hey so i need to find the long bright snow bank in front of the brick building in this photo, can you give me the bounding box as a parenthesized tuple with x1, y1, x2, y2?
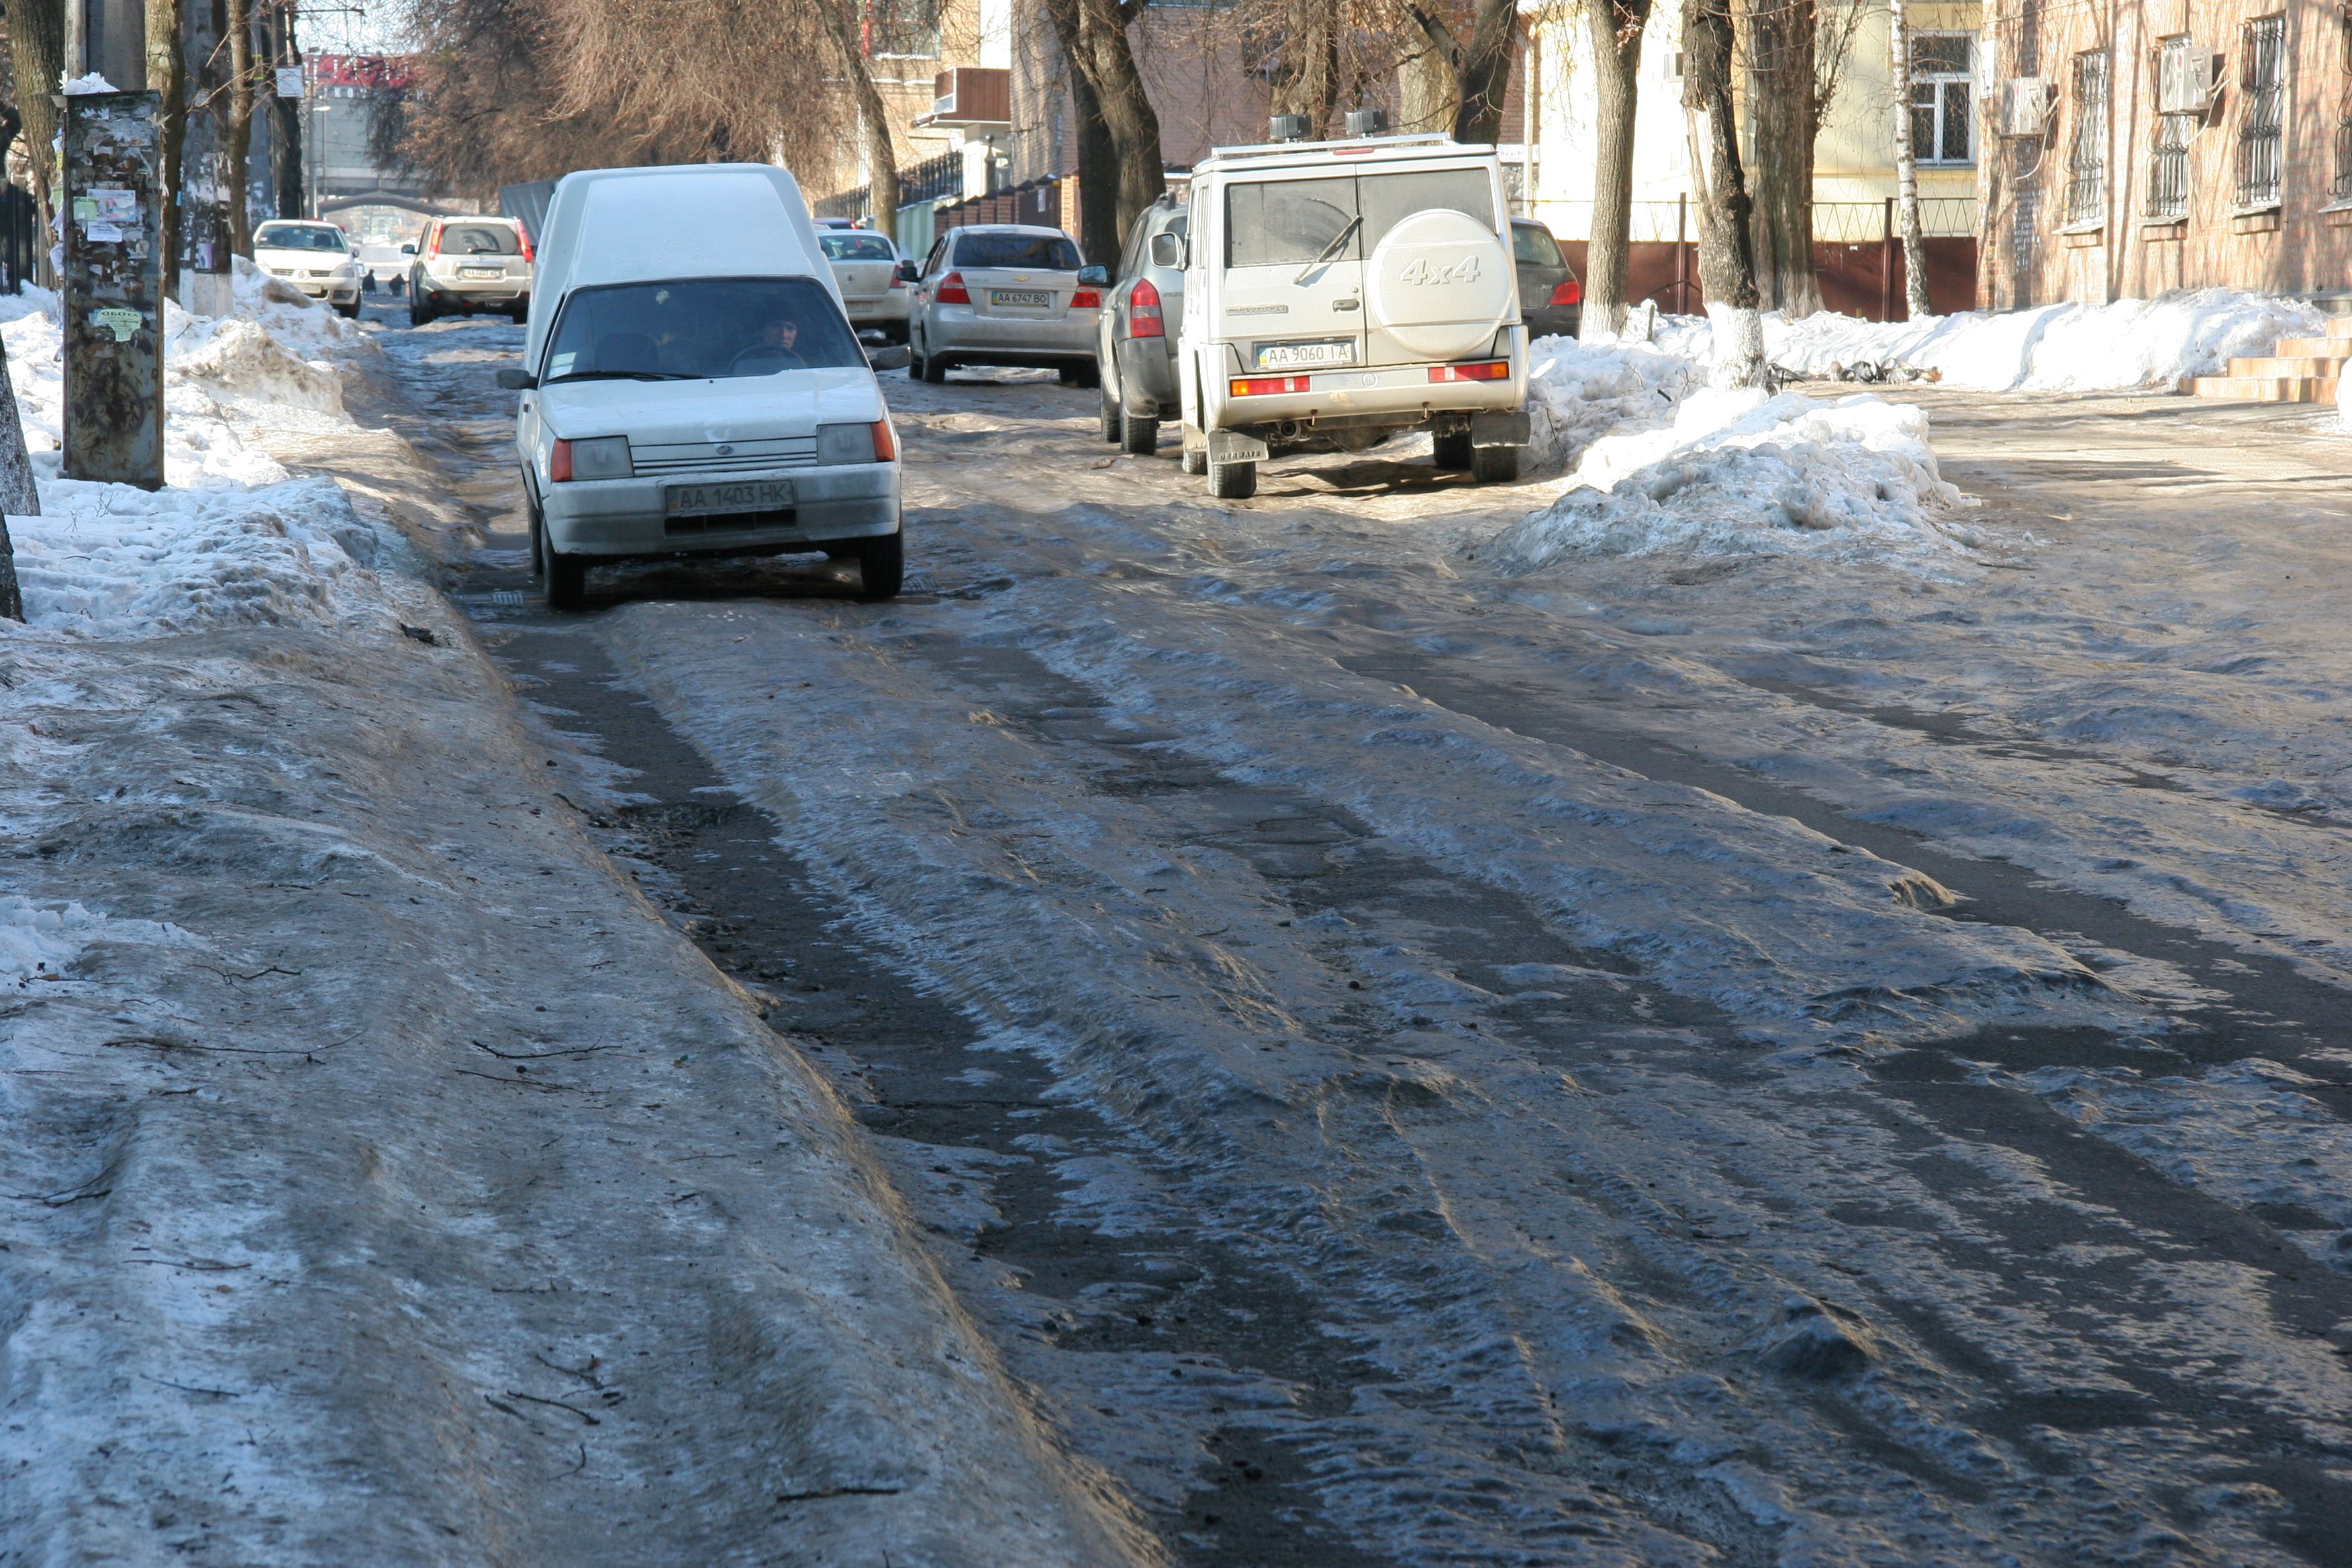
(1764, 289, 2326, 393)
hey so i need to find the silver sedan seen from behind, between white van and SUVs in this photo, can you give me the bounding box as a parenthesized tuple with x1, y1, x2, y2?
(910, 224, 1103, 385)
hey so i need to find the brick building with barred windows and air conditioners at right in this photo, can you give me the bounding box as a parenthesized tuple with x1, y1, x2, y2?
(1978, 0, 2352, 308)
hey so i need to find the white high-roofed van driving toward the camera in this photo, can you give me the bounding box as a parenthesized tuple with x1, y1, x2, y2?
(499, 164, 905, 609)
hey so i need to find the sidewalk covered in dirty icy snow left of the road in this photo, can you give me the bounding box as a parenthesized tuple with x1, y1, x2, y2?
(0, 291, 1129, 1568)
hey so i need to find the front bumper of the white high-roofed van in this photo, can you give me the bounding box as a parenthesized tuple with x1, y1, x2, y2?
(534, 463, 899, 555)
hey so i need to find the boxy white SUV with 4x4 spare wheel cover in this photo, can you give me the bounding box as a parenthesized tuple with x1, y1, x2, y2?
(1171, 136, 1529, 498)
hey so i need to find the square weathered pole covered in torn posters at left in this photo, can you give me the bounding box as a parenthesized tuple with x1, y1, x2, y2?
(59, 92, 164, 489)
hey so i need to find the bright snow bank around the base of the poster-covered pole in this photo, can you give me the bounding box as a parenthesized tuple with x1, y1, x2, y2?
(0, 258, 407, 637)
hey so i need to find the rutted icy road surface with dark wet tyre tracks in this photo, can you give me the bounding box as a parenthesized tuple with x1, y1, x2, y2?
(357, 310, 2352, 1565)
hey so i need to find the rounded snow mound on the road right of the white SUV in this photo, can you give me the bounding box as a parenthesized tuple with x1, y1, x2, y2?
(1470, 388, 1975, 571)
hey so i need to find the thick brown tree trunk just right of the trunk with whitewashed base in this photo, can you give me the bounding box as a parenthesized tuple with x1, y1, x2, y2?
(1747, 0, 1820, 317)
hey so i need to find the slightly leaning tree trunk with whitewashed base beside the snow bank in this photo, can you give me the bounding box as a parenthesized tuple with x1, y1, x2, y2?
(1681, 0, 1764, 388)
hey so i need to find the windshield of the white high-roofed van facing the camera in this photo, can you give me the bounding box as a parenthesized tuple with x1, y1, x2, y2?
(546, 277, 865, 383)
